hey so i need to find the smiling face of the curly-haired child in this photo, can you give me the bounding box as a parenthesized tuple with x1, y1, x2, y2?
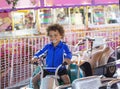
(49, 30, 62, 45)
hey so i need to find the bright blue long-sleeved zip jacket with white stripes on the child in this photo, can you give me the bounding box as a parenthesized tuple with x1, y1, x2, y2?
(34, 41, 72, 72)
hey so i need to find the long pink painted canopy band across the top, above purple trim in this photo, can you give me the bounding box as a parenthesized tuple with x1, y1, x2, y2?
(0, 0, 120, 10)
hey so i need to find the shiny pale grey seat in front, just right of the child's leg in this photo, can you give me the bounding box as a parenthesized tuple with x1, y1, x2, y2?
(72, 76, 101, 89)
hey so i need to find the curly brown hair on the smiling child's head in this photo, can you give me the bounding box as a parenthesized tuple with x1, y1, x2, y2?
(46, 24, 65, 38)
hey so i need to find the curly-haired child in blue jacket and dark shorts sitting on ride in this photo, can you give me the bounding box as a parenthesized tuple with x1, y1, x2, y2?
(31, 24, 72, 89)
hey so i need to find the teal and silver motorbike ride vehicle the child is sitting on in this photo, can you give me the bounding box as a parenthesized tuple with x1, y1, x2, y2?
(29, 56, 84, 89)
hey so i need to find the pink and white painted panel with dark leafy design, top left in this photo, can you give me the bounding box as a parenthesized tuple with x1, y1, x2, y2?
(0, 0, 40, 10)
